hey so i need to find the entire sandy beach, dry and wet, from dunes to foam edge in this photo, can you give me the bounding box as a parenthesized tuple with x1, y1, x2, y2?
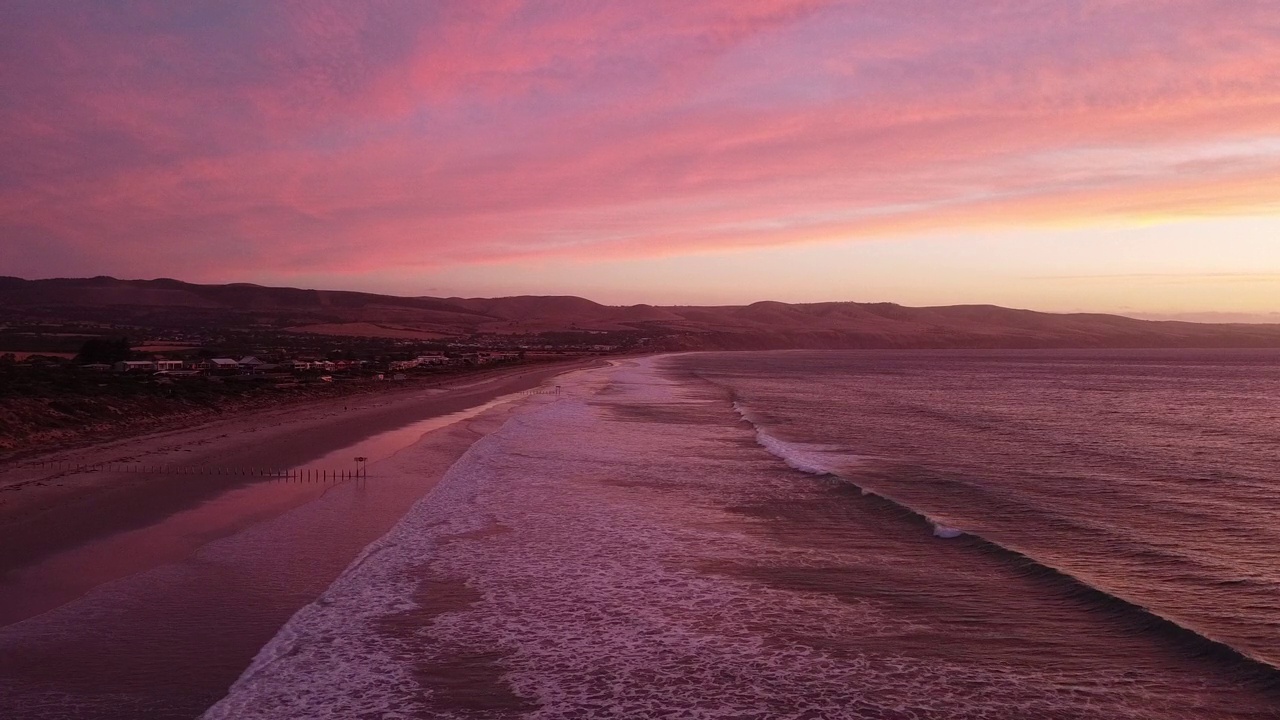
(0, 360, 599, 717)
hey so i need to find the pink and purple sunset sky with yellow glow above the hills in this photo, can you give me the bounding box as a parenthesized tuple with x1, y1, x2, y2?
(0, 0, 1280, 316)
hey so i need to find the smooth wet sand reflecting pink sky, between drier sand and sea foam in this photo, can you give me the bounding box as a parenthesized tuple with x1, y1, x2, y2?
(0, 384, 570, 720)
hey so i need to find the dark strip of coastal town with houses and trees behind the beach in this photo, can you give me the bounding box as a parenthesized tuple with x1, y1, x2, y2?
(0, 323, 637, 456)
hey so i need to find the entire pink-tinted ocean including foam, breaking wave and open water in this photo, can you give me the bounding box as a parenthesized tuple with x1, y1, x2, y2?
(206, 351, 1280, 720)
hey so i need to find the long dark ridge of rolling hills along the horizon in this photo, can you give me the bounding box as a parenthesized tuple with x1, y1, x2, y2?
(0, 277, 1280, 350)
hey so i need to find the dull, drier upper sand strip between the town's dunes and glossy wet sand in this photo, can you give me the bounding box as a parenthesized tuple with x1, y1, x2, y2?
(0, 360, 598, 584)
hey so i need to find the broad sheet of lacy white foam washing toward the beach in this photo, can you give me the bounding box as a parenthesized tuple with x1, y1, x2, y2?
(207, 360, 1198, 720)
